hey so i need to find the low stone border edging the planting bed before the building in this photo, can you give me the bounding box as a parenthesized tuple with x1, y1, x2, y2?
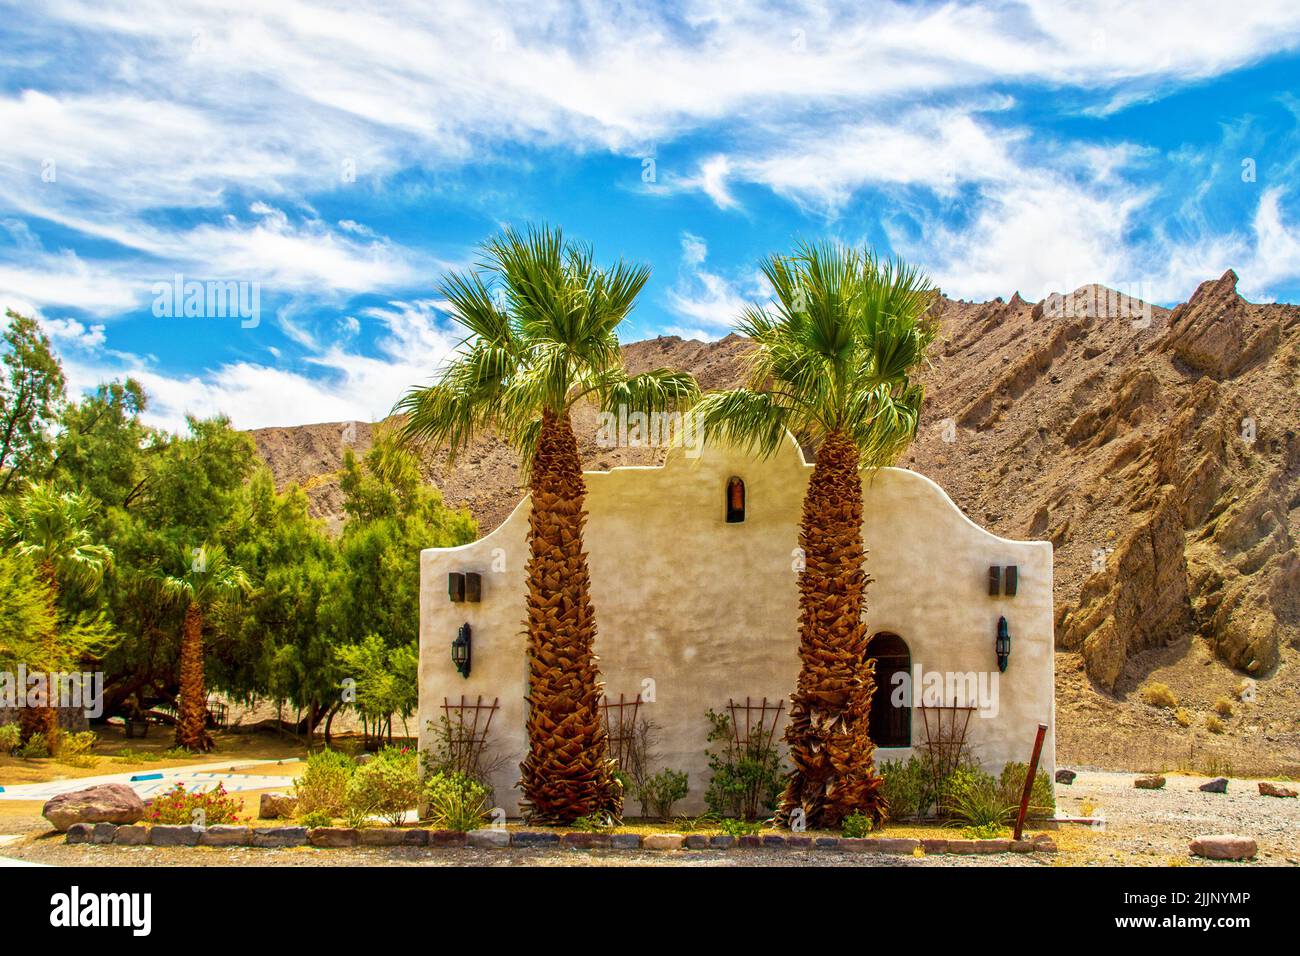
(64, 823, 1057, 856)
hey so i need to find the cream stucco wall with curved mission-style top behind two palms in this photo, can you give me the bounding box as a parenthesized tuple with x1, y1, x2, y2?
(419, 440, 1054, 816)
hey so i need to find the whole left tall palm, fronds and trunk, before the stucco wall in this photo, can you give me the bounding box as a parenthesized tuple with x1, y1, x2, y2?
(398, 226, 698, 822)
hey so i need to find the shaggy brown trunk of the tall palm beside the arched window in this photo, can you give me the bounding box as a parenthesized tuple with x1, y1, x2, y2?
(780, 432, 884, 829)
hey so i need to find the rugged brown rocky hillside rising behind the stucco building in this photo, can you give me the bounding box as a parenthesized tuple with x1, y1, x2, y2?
(254, 272, 1300, 777)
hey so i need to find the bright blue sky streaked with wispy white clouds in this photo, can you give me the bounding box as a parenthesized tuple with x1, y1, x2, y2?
(0, 0, 1300, 428)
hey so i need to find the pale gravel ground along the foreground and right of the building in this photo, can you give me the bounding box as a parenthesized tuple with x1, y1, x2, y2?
(0, 771, 1300, 866)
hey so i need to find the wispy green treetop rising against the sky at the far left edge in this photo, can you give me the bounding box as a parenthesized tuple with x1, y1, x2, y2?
(0, 310, 64, 494)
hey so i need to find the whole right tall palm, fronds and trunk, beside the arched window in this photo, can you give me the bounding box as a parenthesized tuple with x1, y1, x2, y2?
(696, 243, 936, 827)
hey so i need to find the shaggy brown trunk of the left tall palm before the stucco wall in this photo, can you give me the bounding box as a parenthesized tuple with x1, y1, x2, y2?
(520, 412, 623, 823)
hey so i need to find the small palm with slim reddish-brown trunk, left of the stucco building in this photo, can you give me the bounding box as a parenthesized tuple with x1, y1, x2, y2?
(157, 545, 252, 752)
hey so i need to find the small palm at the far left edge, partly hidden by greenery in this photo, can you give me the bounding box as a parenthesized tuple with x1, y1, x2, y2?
(0, 483, 113, 741)
